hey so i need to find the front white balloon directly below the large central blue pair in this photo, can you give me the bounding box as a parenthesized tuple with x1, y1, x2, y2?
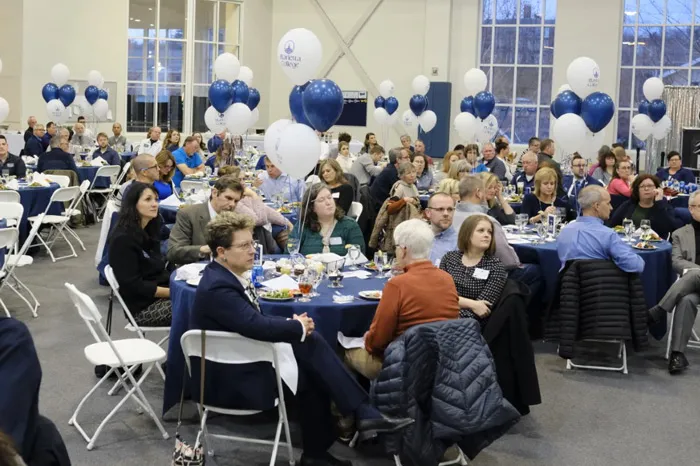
(277, 123, 321, 179)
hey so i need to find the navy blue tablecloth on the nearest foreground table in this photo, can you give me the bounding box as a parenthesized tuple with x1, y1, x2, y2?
(163, 256, 387, 414)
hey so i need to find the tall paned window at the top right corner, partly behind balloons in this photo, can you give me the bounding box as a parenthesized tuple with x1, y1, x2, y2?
(617, 0, 700, 149)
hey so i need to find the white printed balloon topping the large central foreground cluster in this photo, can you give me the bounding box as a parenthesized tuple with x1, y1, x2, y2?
(277, 28, 323, 86)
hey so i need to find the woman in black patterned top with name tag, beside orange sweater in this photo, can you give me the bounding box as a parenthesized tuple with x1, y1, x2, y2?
(440, 214, 508, 326)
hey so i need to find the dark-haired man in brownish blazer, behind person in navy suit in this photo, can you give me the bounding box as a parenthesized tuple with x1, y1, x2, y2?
(168, 176, 243, 265)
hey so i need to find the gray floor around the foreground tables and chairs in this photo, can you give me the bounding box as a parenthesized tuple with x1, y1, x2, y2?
(9, 226, 700, 466)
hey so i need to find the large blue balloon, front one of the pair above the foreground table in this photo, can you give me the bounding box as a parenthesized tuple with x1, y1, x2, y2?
(301, 79, 344, 132)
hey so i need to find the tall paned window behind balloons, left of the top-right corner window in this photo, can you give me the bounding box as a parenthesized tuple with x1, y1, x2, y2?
(479, 0, 556, 144)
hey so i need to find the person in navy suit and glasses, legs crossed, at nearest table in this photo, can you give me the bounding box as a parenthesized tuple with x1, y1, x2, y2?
(191, 212, 412, 466)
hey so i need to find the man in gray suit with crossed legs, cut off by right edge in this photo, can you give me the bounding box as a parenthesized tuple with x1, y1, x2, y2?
(649, 191, 700, 374)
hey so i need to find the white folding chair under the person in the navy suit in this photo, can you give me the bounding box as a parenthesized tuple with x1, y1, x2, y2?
(180, 330, 294, 466)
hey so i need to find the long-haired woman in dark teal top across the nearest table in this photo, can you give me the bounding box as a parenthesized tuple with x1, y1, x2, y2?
(297, 183, 365, 256)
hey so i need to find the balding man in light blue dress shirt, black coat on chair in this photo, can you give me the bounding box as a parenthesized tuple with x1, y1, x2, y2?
(557, 186, 644, 273)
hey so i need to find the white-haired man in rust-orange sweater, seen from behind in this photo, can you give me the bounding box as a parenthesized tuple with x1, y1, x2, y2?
(345, 218, 459, 380)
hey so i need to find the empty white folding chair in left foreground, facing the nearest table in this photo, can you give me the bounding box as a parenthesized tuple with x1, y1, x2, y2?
(66, 283, 169, 450)
